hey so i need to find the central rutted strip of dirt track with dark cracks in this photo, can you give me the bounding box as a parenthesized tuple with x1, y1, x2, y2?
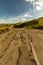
(16, 31, 36, 65)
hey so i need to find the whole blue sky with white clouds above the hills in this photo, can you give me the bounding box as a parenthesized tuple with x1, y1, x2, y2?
(0, 0, 43, 23)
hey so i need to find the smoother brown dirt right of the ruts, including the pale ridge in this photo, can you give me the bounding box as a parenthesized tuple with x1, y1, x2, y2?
(27, 29, 43, 65)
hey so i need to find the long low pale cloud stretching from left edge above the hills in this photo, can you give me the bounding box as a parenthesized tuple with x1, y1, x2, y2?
(0, 13, 33, 23)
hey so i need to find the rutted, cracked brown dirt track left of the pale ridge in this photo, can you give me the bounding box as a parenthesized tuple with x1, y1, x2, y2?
(0, 29, 42, 65)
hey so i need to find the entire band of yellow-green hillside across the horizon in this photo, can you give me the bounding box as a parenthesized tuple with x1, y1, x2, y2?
(0, 17, 43, 33)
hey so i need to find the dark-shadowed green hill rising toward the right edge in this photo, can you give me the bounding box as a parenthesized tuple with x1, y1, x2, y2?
(14, 17, 43, 29)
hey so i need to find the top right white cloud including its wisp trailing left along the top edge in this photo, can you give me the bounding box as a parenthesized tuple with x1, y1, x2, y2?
(25, 0, 43, 11)
